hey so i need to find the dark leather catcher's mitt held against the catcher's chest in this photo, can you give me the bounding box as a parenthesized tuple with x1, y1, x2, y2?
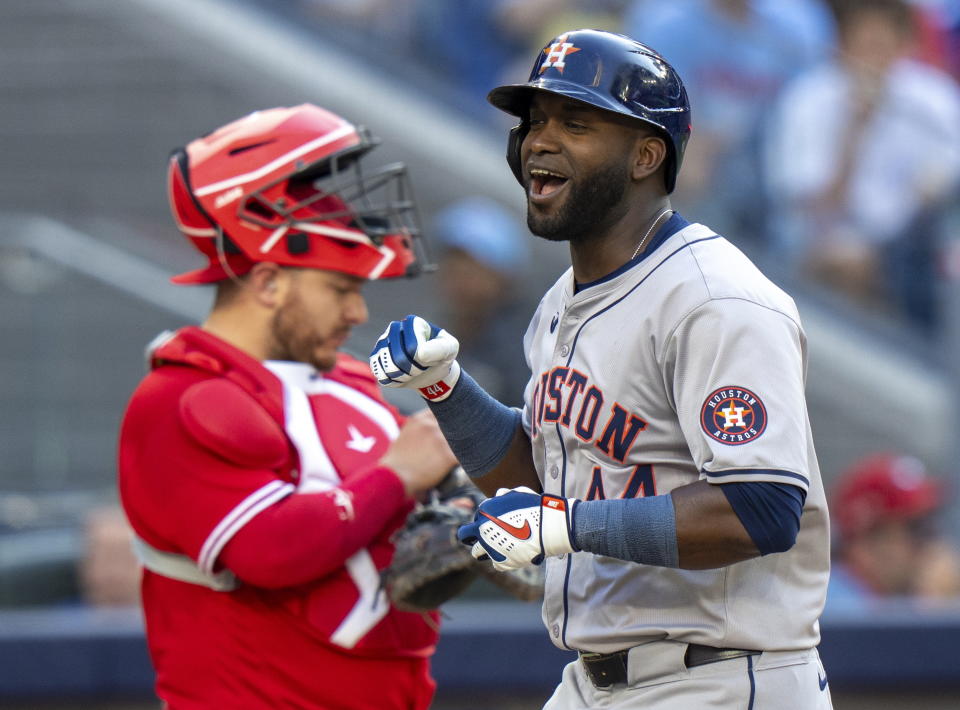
(381, 467, 543, 611)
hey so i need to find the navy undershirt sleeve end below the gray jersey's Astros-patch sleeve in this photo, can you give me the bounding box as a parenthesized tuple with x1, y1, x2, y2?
(720, 481, 807, 555)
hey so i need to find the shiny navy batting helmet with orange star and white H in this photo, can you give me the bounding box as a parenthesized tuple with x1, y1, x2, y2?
(487, 30, 690, 193)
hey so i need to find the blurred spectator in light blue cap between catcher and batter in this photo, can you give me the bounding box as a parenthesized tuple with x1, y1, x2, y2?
(433, 198, 533, 405)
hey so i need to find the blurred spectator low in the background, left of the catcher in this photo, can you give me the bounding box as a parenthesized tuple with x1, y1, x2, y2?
(78, 505, 140, 607)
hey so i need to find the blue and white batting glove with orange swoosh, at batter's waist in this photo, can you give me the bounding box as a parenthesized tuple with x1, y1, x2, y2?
(457, 486, 578, 571)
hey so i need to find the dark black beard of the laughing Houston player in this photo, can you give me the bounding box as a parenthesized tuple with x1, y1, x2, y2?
(527, 162, 629, 242)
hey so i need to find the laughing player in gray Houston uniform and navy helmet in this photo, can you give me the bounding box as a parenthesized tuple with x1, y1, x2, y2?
(371, 30, 831, 710)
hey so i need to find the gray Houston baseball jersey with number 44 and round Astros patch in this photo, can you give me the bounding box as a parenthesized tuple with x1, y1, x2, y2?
(523, 215, 829, 653)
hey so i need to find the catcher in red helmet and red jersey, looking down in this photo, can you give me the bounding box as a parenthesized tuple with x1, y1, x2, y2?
(119, 104, 455, 710)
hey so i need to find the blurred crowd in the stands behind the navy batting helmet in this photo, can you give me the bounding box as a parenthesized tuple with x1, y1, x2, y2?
(299, 0, 960, 335)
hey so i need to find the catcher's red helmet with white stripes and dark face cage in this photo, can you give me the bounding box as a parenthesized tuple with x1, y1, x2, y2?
(167, 104, 422, 284)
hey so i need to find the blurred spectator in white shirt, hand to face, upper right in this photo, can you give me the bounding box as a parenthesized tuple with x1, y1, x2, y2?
(765, 0, 960, 325)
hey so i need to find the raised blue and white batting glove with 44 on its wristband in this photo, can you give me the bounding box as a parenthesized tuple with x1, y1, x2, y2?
(370, 316, 460, 402)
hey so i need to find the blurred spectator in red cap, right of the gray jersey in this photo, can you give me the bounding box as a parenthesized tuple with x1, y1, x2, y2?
(827, 453, 960, 608)
